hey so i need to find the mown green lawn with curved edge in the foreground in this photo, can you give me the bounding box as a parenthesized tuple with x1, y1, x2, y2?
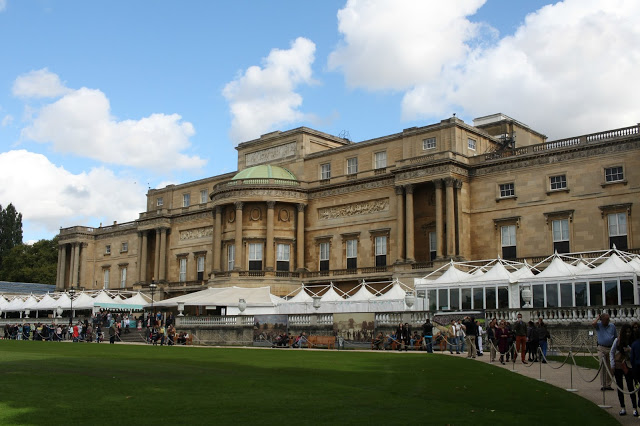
(0, 340, 617, 425)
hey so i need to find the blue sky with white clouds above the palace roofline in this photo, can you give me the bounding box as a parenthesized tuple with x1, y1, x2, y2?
(0, 0, 640, 242)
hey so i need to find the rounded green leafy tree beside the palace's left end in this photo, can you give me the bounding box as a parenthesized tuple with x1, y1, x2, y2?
(0, 236, 58, 284)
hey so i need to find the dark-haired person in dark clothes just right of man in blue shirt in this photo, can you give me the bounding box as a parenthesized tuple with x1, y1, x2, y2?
(609, 324, 638, 417)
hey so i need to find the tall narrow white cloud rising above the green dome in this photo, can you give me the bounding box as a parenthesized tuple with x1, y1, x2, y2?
(222, 37, 316, 143)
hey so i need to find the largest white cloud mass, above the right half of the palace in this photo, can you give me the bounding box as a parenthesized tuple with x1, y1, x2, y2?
(329, 0, 640, 138)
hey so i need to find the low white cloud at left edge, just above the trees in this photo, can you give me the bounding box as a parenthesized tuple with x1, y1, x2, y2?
(0, 150, 146, 234)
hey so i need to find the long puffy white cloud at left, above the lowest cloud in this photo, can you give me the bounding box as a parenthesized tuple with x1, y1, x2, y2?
(14, 69, 206, 170)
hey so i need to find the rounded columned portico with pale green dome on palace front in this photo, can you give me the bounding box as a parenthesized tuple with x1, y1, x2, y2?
(210, 165, 307, 292)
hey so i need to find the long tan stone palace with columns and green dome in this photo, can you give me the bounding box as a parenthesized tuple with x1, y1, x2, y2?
(56, 114, 640, 297)
